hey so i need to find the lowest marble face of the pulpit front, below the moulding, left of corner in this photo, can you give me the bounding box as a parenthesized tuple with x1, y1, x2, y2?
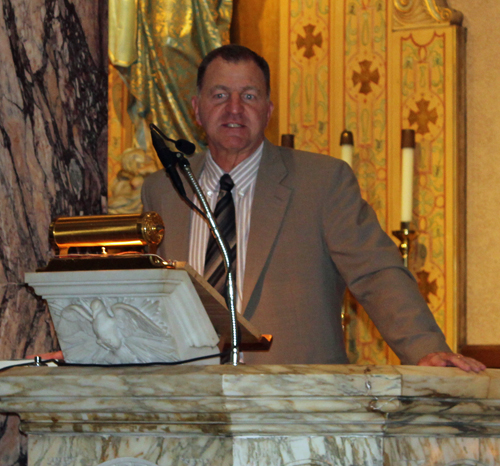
(29, 436, 383, 466)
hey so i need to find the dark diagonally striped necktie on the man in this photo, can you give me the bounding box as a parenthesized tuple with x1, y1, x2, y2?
(204, 173, 236, 298)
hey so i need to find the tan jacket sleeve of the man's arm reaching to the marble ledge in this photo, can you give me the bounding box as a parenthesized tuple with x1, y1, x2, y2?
(323, 163, 451, 364)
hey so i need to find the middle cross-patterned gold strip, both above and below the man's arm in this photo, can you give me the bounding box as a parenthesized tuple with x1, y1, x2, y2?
(342, 0, 389, 364)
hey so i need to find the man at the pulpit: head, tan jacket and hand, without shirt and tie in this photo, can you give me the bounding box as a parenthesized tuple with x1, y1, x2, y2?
(143, 46, 484, 371)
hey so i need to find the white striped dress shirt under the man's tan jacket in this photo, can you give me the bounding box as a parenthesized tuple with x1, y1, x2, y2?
(189, 143, 264, 313)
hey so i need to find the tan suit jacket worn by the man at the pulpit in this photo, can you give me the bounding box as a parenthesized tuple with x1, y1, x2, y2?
(143, 141, 450, 364)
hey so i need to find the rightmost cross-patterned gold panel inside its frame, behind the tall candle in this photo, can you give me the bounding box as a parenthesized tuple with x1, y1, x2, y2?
(400, 33, 446, 327)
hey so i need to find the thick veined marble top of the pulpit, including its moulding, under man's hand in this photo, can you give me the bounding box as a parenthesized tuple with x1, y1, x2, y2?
(0, 365, 500, 436)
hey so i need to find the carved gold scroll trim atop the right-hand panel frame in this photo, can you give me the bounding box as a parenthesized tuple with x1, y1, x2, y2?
(391, 0, 463, 31)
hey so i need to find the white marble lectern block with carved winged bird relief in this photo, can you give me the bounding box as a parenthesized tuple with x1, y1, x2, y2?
(26, 269, 219, 364)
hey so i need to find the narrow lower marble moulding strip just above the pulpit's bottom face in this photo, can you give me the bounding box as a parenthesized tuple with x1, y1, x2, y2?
(12, 408, 500, 437)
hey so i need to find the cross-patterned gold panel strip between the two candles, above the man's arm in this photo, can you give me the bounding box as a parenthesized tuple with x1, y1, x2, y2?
(344, 0, 388, 228)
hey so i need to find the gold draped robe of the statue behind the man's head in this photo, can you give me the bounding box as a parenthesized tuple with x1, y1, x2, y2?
(116, 0, 232, 149)
